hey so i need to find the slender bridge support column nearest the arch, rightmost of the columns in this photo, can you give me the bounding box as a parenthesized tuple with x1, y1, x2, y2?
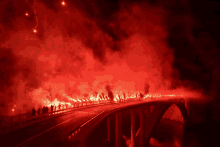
(140, 108, 145, 147)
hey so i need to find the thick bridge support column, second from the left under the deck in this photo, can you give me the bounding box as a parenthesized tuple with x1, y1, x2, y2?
(115, 112, 122, 147)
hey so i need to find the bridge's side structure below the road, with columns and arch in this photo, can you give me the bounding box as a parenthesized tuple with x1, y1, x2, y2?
(68, 99, 188, 147)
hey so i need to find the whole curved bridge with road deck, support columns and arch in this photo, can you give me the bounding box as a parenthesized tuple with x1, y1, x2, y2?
(0, 99, 188, 147)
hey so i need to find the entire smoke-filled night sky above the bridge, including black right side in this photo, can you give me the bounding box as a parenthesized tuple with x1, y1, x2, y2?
(0, 0, 219, 115)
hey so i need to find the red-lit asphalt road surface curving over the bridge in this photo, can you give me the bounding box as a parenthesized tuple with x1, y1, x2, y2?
(0, 105, 116, 147)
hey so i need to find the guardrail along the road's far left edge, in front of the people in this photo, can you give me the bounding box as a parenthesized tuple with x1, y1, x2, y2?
(0, 101, 117, 134)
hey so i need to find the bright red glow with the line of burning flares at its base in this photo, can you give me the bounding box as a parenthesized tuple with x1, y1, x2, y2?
(0, 1, 204, 116)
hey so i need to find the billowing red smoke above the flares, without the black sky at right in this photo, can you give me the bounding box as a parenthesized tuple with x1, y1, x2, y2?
(0, 1, 210, 115)
